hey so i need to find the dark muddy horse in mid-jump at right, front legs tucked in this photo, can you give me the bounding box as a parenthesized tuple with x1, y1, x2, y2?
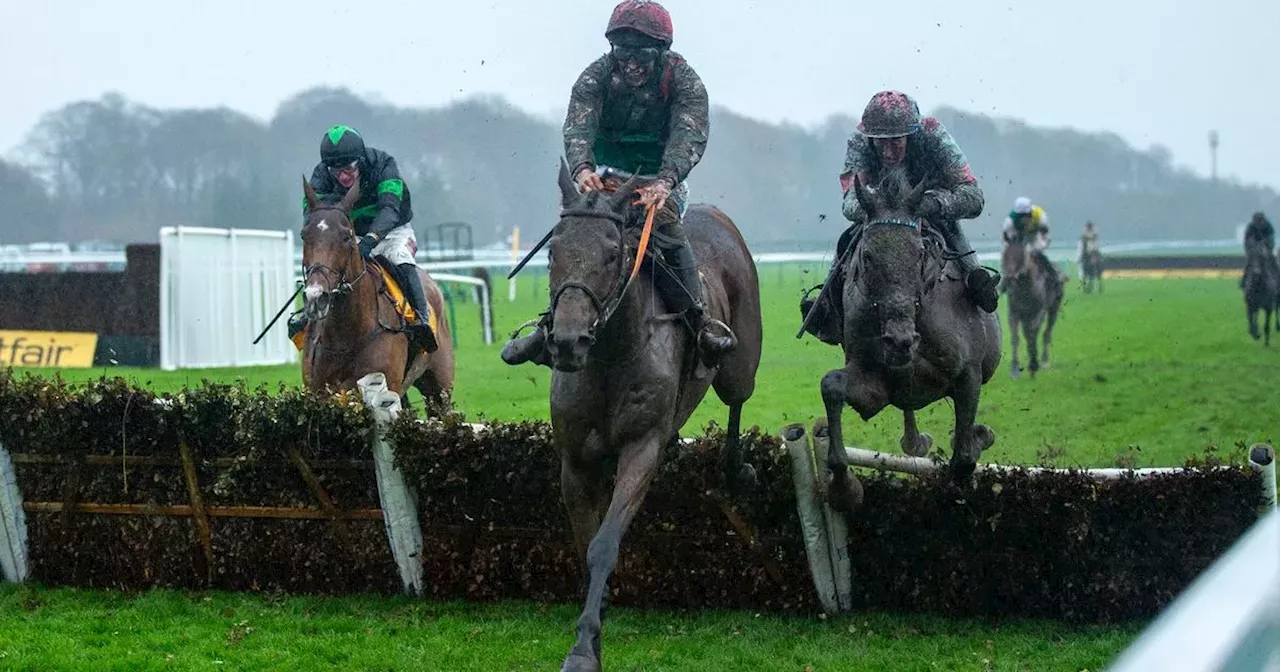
(822, 170, 1001, 515)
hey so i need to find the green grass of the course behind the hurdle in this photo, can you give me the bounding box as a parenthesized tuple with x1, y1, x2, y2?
(27, 266, 1280, 466)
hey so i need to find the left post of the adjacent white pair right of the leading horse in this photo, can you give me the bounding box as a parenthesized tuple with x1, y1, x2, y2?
(782, 422, 840, 614)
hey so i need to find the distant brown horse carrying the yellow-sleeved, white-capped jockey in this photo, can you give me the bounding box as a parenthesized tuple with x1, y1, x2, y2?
(1000, 231, 1064, 380)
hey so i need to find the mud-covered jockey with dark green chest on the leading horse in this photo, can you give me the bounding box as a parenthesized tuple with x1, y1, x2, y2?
(502, 0, 736, 366)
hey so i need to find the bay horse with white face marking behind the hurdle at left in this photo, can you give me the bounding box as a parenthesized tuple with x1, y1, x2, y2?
(302, 179, 453, 413)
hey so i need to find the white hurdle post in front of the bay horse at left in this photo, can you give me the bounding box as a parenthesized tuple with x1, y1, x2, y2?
(356, 372, 422, 595)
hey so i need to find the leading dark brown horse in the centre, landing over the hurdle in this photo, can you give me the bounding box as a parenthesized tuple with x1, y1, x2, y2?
(547, 161, 763, 671)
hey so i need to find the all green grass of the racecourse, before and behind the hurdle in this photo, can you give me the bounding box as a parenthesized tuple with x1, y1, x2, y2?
(0, 268, 1280, 671)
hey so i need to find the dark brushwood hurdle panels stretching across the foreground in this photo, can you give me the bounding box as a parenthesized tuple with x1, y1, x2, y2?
(0, 372, 1261, 622)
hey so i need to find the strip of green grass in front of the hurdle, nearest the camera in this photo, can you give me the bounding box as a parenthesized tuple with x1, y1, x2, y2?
(0, 586, 1137, 672)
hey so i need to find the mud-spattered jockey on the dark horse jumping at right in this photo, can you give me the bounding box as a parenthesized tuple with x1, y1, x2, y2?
(800, 91, 998, 344)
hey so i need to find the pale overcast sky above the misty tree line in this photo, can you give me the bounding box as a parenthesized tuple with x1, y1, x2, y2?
(0, 0, 1280, 187)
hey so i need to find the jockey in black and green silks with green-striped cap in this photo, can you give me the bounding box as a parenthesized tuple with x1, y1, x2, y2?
(289, 125, 436, 352)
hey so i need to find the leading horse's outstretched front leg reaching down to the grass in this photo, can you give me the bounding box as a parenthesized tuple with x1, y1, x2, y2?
(561, 429, 669, 671)
